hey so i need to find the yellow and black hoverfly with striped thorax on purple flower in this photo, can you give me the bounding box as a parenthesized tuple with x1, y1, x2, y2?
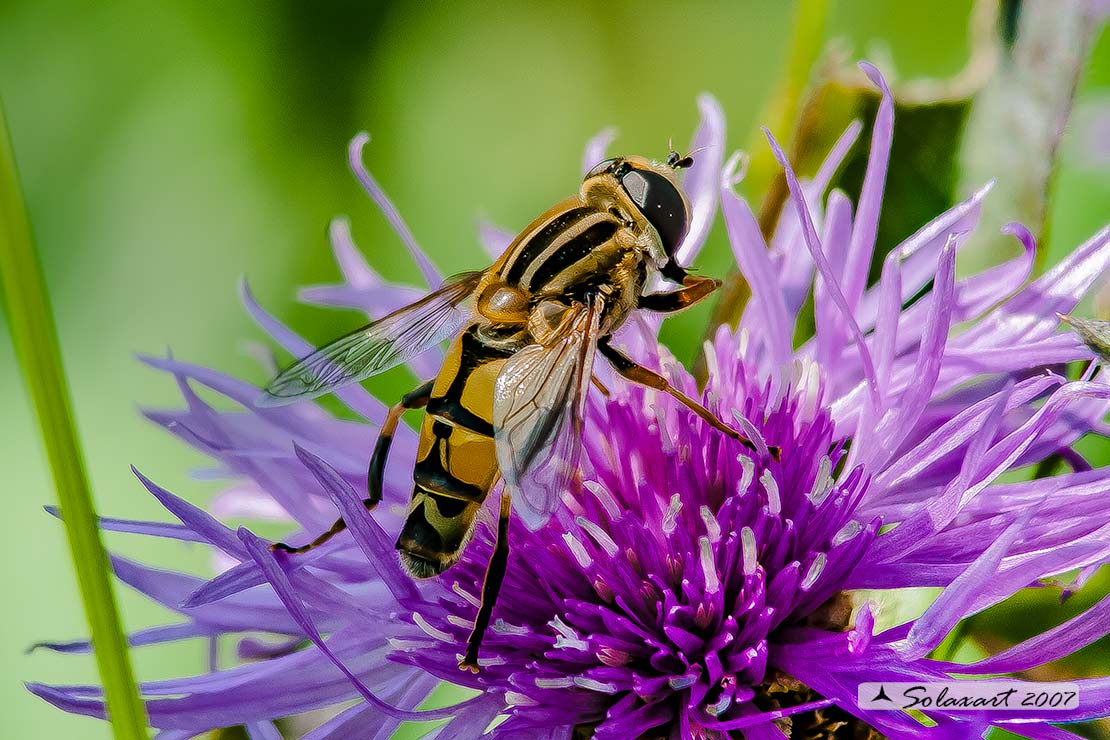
(262, 151, 751, 672)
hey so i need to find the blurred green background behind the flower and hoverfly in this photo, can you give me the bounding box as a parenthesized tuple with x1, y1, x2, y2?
(0, 0, 1110, 739)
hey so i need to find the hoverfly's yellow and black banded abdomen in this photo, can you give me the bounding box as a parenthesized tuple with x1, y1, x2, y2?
(396, 325, 512, 578)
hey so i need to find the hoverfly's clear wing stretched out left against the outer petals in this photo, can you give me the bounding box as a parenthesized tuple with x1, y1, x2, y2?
(264, 272, 483, 406)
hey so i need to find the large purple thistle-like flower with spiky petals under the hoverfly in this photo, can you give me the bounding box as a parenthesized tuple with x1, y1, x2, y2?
(30, 65, 1110, 740)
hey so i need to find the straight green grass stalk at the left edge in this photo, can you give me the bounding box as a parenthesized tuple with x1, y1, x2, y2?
(0, 99, 148, 740)
